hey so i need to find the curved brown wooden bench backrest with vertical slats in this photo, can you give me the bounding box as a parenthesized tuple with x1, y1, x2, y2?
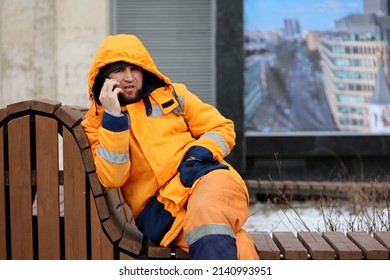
(0, 100, 139, 259)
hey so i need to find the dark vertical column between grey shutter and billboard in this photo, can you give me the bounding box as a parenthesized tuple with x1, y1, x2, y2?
(216, 0, 246, 175)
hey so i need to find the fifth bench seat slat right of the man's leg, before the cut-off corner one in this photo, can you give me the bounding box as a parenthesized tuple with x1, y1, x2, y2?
(347, 232, 389, 260)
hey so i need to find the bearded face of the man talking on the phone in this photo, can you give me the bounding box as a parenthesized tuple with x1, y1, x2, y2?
(108, 65, 144, 106)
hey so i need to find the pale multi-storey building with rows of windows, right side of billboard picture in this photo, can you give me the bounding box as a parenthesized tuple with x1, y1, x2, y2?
(319, 0, 390, 132)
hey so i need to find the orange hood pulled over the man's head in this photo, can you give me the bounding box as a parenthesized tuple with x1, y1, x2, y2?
(88, 34, 171, 103)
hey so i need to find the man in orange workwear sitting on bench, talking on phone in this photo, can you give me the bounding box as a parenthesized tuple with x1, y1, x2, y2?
(82, 34, 257, 259)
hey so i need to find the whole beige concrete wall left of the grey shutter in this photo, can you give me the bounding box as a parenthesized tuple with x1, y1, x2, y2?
(0, 0, 111, 108)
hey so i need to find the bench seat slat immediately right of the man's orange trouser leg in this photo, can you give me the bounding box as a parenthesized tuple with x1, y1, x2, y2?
(250, 231, 280, 260)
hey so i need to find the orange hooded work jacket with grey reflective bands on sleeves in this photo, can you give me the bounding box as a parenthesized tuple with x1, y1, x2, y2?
(82, 34, 247, 246)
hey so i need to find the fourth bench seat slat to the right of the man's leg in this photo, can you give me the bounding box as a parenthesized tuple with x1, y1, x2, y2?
(322, 231, 362, 260)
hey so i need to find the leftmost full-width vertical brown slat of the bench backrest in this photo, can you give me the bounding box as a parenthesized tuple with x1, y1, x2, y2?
(8, 115, 33, 260)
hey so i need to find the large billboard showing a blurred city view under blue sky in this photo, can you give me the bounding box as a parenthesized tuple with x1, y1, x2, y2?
(244, 0, 390, 134)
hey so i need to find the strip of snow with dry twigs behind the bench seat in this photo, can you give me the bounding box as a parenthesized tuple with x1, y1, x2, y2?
(244, 201, 390, 233)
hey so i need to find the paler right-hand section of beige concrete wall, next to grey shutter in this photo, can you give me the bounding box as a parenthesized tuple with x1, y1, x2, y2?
(56, 0, 111, 107)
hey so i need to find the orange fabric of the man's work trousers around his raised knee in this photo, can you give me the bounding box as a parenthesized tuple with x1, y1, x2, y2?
(172, 170, 258, 260)
